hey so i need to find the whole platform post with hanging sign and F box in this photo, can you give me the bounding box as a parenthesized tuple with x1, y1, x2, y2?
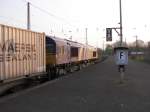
(106, 0, 128, 83)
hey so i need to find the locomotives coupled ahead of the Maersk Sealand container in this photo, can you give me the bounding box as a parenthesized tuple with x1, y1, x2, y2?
(46, 36, 98, 78)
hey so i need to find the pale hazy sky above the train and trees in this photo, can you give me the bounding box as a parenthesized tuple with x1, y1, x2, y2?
(0, 0, 150, 48)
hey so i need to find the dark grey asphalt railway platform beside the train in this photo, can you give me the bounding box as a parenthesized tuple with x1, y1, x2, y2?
(0, 57, 150, 112)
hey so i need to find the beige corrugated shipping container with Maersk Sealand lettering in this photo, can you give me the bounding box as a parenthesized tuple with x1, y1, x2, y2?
(0, 25, 46, 81)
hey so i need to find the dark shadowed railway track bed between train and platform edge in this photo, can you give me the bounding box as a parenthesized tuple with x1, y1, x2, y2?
(0, 58, 103, 98)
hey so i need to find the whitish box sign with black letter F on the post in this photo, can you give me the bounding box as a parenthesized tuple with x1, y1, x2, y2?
(116, 49, 128, 65)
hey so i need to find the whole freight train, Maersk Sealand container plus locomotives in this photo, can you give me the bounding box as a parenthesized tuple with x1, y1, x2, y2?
(0, 25, 101, 83)
